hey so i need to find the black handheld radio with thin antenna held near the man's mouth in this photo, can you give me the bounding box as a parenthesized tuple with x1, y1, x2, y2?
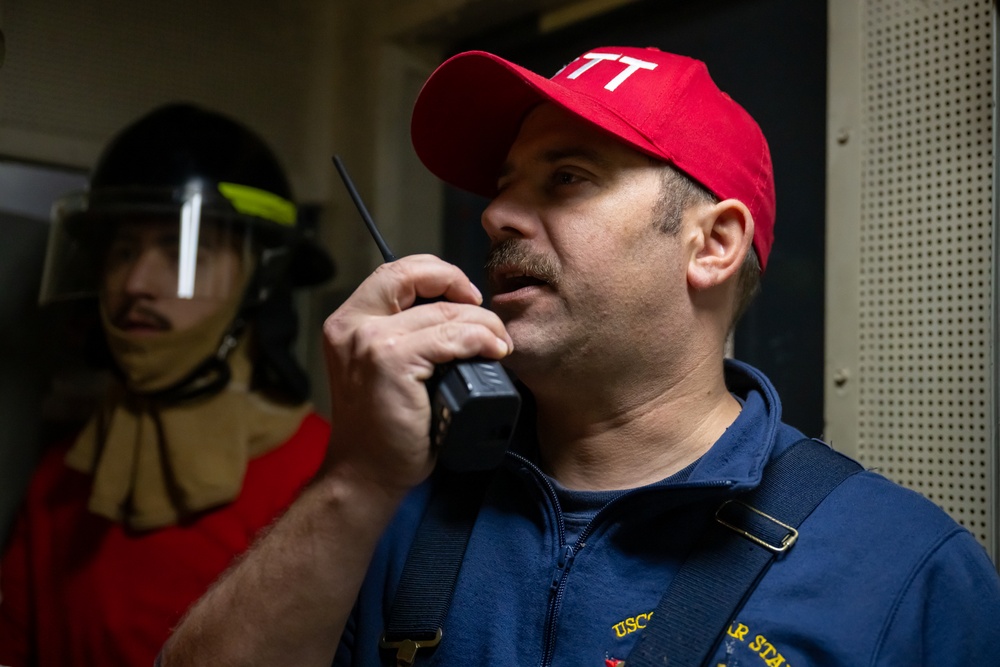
(333, 155, 521, 472)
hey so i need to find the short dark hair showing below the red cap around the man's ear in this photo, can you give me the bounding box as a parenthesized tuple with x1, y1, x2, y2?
(650, 158, 761, 331)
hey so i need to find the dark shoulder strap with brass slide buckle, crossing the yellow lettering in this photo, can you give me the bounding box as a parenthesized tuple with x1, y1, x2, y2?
(625, 440, 861, 667)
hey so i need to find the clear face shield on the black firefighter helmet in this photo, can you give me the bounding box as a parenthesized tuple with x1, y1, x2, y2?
(39, 188, 255, 329)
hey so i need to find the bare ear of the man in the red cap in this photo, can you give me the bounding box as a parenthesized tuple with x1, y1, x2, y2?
(688, 199, 754, 289)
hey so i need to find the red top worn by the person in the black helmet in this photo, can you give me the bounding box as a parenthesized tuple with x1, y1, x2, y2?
(0, 413, 330, 667)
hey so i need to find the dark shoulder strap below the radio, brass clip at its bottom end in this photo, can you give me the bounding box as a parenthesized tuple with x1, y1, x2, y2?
(379, 471, 493, 667)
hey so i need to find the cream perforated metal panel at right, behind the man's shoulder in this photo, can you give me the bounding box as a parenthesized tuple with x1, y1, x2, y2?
(857, 0, 996, 546)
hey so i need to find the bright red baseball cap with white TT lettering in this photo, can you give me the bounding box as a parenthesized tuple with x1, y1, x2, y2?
(410, 46, 775, 269)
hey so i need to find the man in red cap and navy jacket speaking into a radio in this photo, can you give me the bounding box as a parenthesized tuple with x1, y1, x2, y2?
(161, 47, 1000, 667)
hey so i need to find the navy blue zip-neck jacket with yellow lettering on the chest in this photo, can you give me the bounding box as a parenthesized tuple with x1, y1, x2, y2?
(334, 362, 1000, 667)
